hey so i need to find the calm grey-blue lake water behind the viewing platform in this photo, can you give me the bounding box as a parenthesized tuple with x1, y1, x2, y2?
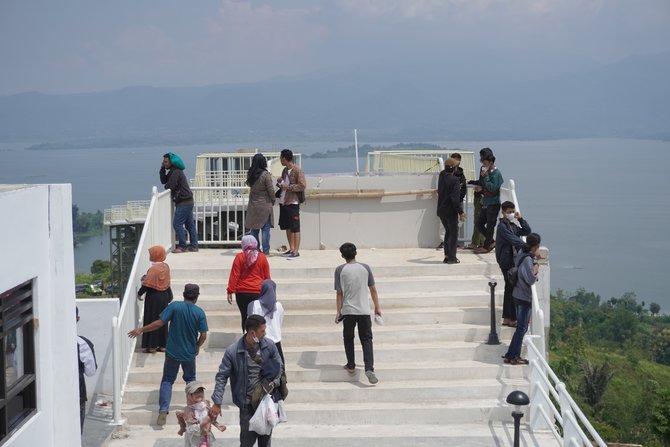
(0, 139, 670, 312)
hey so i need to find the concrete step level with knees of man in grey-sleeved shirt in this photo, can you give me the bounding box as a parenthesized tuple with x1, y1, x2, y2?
(207, 323, 514, 348)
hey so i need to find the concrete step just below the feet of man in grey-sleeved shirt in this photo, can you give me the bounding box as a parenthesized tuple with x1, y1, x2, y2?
(124, 378, 526, 406)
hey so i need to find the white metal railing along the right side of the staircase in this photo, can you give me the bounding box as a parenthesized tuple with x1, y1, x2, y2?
(500, 180, 607, 447)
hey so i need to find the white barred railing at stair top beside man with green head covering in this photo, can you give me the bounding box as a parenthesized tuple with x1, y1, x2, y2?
(191, 186, 249, 245)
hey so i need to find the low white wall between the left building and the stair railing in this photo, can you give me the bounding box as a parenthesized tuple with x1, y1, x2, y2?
(77, 298, 119, 400)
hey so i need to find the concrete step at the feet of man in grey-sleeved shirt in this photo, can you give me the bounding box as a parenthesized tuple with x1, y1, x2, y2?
(128, 358, 526, 387)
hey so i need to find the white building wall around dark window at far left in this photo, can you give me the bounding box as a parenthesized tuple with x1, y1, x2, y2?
(0, 185, 81, 447)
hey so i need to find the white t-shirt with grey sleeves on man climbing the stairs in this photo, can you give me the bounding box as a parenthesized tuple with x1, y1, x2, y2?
(335, 262, 375, 315)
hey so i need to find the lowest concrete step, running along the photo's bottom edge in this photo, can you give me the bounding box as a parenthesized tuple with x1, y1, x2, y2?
(106, 424, 559, 447)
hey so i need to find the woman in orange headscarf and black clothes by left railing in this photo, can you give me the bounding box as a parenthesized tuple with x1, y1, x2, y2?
(137, 245, 172, 354)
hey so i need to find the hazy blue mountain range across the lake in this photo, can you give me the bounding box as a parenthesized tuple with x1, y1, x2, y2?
(0, 53, 670, 145)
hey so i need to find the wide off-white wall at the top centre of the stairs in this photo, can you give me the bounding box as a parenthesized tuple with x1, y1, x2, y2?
(271, 174, 440, 250)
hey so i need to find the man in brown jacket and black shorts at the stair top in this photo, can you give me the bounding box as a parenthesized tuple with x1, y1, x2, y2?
(277, 149, 307, 259)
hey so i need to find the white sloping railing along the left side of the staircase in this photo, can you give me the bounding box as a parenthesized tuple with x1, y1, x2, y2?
(112, 187, 172, 425)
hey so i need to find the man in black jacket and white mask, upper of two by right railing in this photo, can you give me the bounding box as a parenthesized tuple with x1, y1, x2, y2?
(496, 201, 531, 327)
